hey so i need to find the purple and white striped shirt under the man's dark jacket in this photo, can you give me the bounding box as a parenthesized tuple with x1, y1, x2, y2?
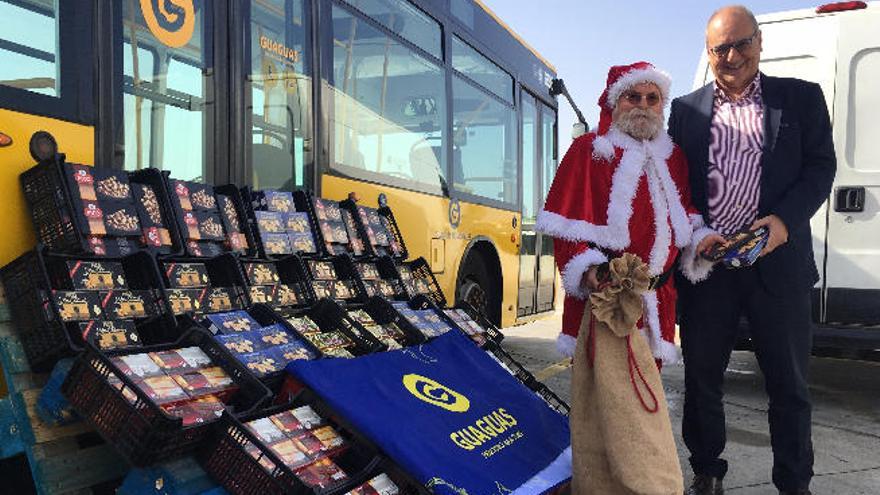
(708, 74, 764, 235)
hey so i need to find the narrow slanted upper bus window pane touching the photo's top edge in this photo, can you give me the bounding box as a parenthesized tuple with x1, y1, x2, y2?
(346, 0, 443, 60)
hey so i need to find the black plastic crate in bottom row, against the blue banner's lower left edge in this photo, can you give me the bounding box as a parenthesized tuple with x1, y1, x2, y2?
(199, 393, 382, 495)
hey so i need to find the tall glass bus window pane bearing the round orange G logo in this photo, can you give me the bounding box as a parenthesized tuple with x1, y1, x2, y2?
(122, 0, 213, 180)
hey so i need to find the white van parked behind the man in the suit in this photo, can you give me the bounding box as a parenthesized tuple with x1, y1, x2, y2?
(694, 2, 880, 349)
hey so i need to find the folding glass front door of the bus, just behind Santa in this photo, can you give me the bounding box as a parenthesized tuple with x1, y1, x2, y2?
(517, 91, 556, 317)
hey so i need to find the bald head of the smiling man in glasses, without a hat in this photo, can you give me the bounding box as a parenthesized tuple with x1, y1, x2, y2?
(706, 5, 761, 98)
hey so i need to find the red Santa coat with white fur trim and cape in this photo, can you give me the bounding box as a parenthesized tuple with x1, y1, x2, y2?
(537, 127, 712, 363)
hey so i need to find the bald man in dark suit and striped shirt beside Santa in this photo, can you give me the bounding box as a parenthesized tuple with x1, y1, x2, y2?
(669, 6, 836, 495)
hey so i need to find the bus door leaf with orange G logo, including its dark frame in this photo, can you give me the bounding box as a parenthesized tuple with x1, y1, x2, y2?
(115, 0, 220, 183)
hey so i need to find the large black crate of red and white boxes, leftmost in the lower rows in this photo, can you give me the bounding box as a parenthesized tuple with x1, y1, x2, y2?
(61, 329, 271, 467)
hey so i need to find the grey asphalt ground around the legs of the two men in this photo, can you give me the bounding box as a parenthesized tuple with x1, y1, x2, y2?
(503, 313, 880, 495)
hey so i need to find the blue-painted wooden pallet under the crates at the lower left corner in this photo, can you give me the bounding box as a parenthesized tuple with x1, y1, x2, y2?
(0, 305, 128, 495)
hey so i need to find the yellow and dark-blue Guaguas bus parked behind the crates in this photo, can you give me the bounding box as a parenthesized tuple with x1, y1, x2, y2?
(0, 0, 557, 326)
